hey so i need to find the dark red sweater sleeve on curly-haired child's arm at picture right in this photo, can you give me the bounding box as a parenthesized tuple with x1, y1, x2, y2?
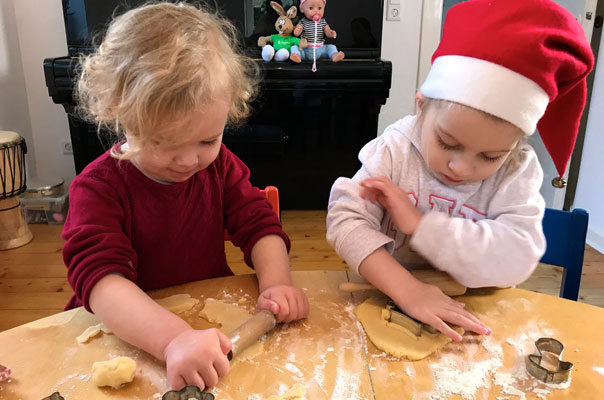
(219, 145, 290, 268)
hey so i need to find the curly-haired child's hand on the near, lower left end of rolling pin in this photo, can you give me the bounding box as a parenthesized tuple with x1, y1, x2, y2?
(164, 329, 232, 390)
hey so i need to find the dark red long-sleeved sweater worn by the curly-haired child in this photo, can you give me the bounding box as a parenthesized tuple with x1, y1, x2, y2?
(62, 145, 290, 311)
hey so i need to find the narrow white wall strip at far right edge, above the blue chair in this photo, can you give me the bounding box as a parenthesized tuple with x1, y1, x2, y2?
(573, 33, 604, 253)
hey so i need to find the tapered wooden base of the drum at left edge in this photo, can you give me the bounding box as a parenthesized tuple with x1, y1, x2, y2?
(0, 196, 33, 250)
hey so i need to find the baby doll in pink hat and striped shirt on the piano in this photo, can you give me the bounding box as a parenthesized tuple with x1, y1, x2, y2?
(294, 0, 344, 71)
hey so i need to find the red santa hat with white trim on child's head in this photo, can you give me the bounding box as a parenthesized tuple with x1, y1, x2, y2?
(420, 0, 594, 182)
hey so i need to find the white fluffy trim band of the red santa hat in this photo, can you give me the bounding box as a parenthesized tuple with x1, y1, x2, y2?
(419, 56, 549, 135)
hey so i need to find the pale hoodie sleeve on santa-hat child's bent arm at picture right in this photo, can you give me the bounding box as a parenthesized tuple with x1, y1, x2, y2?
(410, 149, 545, 287)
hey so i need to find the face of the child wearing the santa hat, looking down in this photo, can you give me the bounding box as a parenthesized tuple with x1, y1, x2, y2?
(421, 104, 522, 186)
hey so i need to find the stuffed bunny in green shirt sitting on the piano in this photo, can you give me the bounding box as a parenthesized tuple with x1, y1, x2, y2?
(258, 1, 307, 63)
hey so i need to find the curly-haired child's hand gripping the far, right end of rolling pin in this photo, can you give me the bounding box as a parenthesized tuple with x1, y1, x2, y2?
(258, 285, 309, 322)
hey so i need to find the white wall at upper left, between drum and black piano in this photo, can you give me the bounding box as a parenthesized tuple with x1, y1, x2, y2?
(0, 0, 75, 182)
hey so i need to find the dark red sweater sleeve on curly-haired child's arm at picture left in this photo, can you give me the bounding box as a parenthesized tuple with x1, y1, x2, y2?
(62, 175, 137, 312)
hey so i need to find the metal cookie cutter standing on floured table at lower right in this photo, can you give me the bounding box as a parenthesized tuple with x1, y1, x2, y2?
(526, 338, 573, 383)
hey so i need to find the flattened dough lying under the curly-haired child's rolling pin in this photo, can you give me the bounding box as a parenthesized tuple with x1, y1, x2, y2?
(199, 299, 264, 366)
